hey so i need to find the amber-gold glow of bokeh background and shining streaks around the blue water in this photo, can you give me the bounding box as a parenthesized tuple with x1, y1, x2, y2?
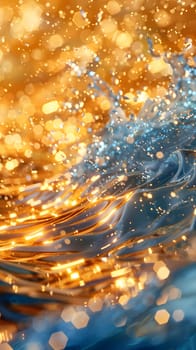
(0, 0, 196, 349)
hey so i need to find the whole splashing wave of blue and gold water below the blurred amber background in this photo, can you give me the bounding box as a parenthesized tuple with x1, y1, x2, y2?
(0, 50, 196, 350)
